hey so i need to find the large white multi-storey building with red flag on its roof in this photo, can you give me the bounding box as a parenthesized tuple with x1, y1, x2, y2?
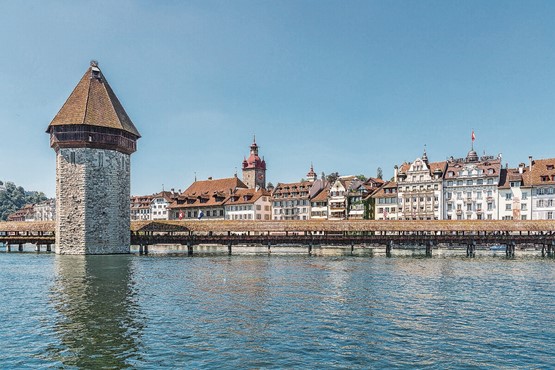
(443, 149, 501, 220)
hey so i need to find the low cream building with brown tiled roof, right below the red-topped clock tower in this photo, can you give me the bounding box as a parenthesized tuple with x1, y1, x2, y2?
(224, 189, 272, 220)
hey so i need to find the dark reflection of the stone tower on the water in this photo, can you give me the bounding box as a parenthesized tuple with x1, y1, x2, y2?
(49, 256, 142, 368)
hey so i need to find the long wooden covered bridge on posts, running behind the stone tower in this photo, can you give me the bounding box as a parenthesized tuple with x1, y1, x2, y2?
(0, 220, 555, 255)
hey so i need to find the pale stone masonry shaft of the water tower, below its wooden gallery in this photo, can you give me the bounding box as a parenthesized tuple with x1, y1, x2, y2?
(56, 148, 131, 254)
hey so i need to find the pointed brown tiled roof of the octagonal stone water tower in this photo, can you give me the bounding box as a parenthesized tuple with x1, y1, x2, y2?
(47, 62, 141, 137)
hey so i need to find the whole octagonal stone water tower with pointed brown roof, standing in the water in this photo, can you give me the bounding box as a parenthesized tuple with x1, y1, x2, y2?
(46, 61, 141, 254)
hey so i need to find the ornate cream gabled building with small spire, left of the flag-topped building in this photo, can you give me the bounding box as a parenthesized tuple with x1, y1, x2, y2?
(397, 150, 447, 220)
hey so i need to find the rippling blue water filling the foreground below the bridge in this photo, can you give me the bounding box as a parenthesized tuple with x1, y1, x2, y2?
(0, 253, 555, 369)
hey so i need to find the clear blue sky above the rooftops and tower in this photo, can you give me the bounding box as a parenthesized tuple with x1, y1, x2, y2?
(0, 0, 555, 196)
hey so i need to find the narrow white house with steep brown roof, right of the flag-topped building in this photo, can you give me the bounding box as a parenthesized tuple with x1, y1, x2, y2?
(497, 163, 532, 220)
